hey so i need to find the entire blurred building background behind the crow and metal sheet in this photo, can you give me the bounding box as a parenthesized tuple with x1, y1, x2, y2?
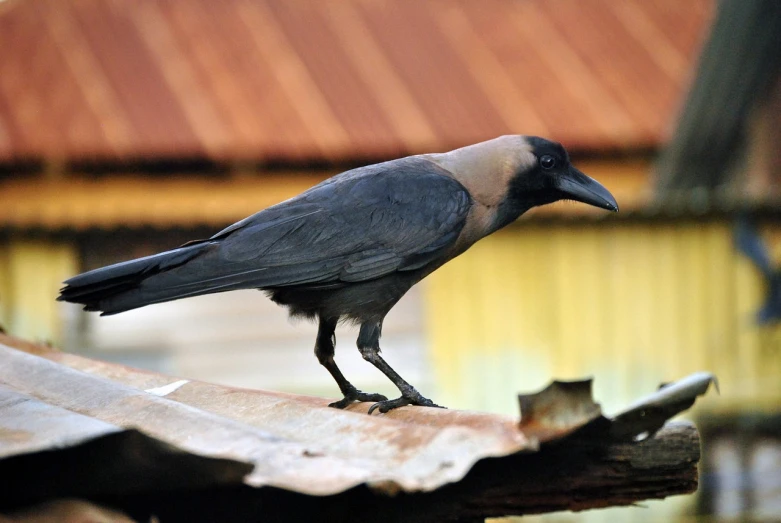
(0, 0, 781, 521)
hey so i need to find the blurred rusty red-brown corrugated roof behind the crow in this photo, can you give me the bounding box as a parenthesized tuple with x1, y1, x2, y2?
(0, 0, 715, 161)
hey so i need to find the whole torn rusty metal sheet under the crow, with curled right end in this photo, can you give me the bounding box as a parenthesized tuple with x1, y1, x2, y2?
(0, 335, 709, 504)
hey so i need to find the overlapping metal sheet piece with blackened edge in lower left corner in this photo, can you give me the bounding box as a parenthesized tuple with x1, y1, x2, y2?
(0, 398, 253, 506)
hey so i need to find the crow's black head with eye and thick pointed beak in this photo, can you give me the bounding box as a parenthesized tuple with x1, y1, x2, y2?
(507, 136, 618, 212)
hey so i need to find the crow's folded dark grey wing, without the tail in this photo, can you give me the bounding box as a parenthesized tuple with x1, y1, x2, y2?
(158, 158, 471, 288)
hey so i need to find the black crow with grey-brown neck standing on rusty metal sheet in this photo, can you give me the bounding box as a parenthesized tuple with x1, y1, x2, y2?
(57, 135, 618, 415)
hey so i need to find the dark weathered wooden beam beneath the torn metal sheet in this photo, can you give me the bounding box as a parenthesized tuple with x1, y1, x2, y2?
(87, 422, 700, 523)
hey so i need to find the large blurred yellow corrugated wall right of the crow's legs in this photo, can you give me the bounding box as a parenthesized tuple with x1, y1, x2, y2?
(426, 221, 781, 413)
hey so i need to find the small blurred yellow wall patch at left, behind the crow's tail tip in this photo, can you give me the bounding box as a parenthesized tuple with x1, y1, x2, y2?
(0, 240, 78, 343)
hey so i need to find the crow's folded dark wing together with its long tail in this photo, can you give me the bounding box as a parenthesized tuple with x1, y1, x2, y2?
(58, 158, 471, 316)
